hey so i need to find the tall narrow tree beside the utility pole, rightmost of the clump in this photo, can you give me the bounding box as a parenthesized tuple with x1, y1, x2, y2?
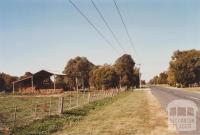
(114, 54, 135, 88)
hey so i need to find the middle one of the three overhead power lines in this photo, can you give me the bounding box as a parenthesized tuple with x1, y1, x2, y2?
(90, 0, 125, 52)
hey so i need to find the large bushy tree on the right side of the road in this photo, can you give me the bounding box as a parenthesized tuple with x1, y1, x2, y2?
(168, 49, 200, 87)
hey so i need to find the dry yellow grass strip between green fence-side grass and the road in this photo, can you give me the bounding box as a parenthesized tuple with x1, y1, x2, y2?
(56, 91, 176, 135)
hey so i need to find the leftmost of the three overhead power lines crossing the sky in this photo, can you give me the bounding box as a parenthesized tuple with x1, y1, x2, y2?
(69, 0, 119, 53)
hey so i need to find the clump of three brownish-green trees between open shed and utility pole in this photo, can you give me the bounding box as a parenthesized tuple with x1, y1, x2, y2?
(61, 54, 139, 89)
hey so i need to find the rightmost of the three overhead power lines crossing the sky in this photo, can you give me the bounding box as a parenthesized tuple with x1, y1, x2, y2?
(113, 0, 137, 56)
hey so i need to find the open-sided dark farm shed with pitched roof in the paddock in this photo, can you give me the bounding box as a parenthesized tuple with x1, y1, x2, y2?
(13, 70, 65, 93)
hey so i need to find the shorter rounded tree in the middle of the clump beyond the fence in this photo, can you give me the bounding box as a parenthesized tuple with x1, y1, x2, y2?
(90, 65, 119, 89)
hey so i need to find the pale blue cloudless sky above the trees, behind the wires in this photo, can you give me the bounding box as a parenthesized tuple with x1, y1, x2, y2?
(0, 0, 200, 80)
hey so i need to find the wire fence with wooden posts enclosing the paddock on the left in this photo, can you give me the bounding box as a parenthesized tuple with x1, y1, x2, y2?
(0, 89, 121, 131)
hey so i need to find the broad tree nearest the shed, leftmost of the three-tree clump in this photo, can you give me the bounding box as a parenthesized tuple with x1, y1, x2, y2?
(63, 57, 94, 89)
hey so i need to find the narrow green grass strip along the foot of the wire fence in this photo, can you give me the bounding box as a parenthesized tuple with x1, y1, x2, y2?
(11, 93, 127, 135)
